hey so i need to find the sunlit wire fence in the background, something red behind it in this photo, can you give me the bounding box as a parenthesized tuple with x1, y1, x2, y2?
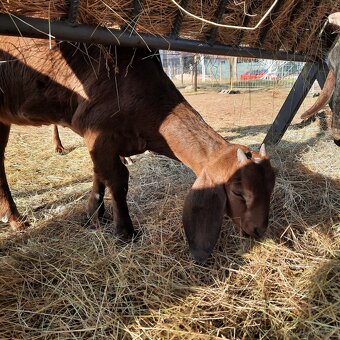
(161, 51, 319, 91)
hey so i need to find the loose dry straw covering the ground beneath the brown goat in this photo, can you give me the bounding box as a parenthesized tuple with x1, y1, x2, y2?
(0, 89, 340, 339)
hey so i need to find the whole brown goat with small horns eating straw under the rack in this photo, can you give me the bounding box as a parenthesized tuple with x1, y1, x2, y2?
(0, 37, 275, 262)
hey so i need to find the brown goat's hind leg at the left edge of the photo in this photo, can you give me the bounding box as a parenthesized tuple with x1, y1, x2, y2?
(0, 123, 29, 230)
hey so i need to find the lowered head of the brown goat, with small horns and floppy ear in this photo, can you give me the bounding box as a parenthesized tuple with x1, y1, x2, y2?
(183, 145, 275, 263)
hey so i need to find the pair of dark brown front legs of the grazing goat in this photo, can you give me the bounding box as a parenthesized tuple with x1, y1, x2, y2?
(85, 135, 134, 239)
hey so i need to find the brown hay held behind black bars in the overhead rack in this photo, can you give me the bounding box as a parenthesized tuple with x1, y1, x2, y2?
(0, 0, 339, 56)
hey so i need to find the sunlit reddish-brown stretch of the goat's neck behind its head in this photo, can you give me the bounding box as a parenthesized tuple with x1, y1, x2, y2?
(160, 103, 229, 176)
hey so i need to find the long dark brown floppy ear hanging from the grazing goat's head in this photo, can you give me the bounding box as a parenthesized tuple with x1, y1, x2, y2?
(183, 171, 227, 263)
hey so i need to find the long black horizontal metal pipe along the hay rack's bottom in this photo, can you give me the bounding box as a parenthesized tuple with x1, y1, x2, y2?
(0, 14, 311, 61)
